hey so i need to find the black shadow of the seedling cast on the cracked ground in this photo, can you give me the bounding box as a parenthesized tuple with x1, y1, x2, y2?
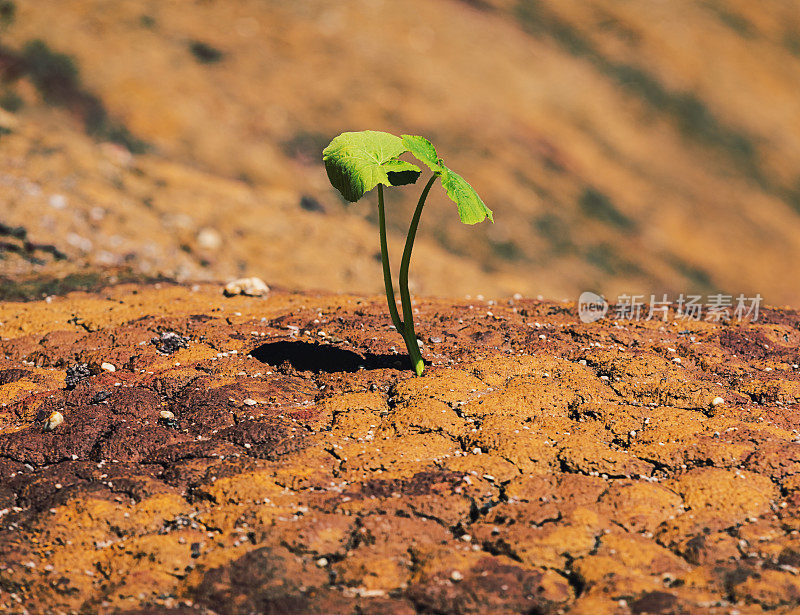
(250, 342, 411, 374)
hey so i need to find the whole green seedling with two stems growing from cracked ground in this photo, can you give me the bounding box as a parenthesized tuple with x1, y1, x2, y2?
(322, 130, 494, 376)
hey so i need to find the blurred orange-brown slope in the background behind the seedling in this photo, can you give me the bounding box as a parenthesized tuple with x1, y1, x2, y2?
(0, 0, 800, 306)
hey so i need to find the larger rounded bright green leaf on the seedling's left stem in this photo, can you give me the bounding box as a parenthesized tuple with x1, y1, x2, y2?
(322, 130, 420, 203)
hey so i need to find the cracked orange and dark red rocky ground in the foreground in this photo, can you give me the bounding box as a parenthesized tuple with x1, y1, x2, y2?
(0, 283, 800, 615)
